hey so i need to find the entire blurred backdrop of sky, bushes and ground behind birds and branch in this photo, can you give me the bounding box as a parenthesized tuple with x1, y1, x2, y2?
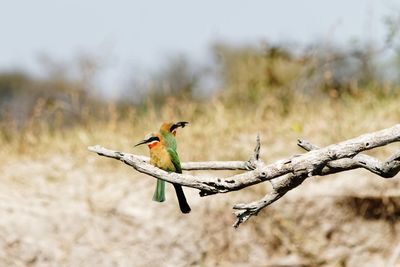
(0, 0, 400, 266)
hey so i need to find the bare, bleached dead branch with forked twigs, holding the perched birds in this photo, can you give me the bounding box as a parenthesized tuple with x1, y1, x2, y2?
(88, 124, 400, 227)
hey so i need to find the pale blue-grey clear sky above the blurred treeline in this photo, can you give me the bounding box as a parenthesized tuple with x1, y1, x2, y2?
(0, 0, 400, 93)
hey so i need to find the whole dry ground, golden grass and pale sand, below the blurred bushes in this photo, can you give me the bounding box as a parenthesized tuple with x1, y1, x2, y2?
(0, 93, 400, 266)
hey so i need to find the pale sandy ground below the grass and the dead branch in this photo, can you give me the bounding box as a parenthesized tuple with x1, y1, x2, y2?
(0, 154, 400, 267)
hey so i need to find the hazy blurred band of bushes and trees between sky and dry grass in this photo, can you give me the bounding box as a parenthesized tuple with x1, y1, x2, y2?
(0, 29, 400, 154)
